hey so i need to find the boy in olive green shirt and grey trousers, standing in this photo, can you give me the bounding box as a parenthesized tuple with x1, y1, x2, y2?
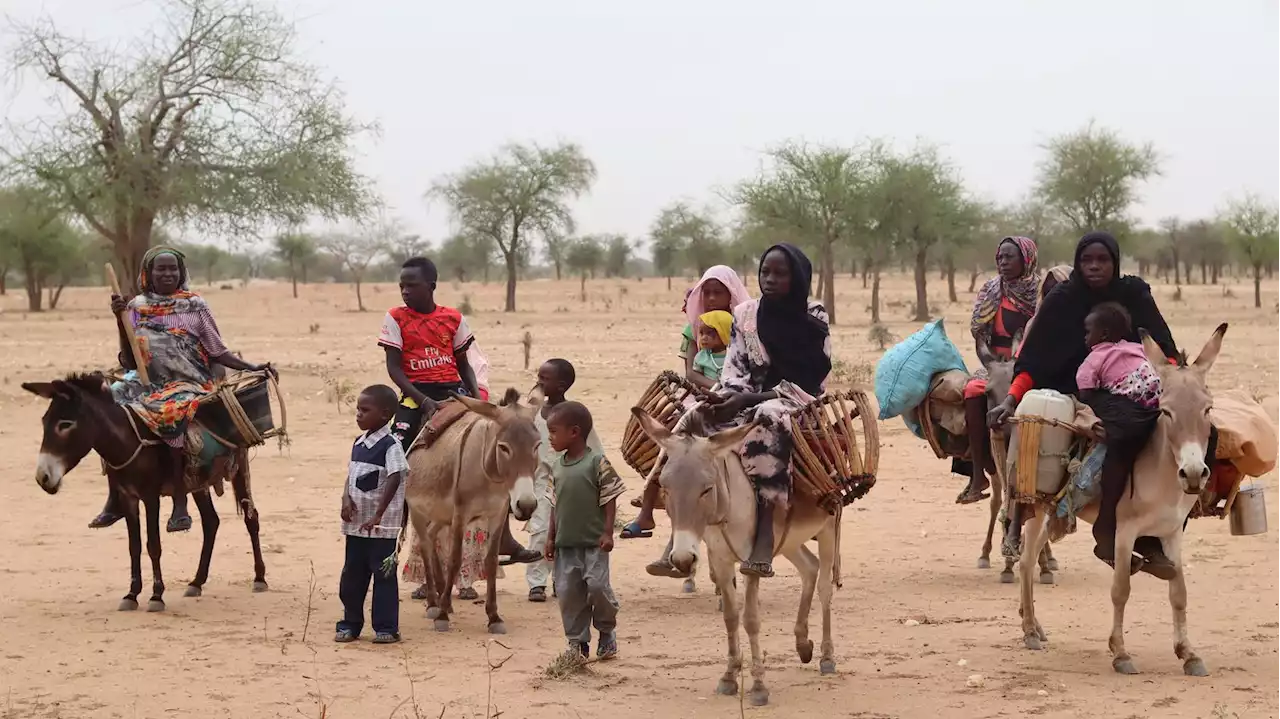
(547, 402, 626, 659)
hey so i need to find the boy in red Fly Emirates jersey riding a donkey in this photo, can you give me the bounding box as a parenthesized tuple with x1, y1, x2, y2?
(378, 257, 543, 564)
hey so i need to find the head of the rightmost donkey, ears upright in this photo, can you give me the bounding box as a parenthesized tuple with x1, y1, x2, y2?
(1142, 322, 1226, 494)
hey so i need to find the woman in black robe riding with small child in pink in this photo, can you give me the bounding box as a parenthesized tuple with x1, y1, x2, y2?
(988, 232, 1187, 580)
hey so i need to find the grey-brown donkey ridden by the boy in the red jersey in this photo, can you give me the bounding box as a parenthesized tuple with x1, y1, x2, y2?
(404, 389, 539, 635)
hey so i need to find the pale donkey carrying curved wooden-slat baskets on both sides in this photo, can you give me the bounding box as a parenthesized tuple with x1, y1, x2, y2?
(631, 407, 840, 706)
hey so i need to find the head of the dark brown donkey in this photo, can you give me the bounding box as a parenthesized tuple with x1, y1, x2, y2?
(22, 374, 111, 494)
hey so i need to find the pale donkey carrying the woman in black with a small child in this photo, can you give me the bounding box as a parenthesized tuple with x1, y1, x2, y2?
(1019, 324, 1226, 677)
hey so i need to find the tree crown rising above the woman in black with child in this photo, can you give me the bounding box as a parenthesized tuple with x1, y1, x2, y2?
(1036, 122, 1160, 233)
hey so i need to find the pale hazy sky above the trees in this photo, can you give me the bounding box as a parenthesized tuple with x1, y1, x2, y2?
(0, 0, 1280, 248)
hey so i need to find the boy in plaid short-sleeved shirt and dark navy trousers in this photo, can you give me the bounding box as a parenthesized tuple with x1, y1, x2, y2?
(334, 385, 408, 644)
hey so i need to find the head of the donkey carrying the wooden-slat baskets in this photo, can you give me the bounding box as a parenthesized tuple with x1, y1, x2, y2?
(631, 407, 754, 572)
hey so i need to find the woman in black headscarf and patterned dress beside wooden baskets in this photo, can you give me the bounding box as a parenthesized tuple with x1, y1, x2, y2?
(707, 244, 831, 577)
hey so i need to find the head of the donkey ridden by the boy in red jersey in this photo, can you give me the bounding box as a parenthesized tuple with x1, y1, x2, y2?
(458, 389, 540, 522)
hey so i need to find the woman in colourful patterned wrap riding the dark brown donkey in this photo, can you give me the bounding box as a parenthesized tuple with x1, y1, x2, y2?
(88, 246, 270, 532)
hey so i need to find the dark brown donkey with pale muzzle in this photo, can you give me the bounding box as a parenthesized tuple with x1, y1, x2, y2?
(22, 374, 266, 612)
